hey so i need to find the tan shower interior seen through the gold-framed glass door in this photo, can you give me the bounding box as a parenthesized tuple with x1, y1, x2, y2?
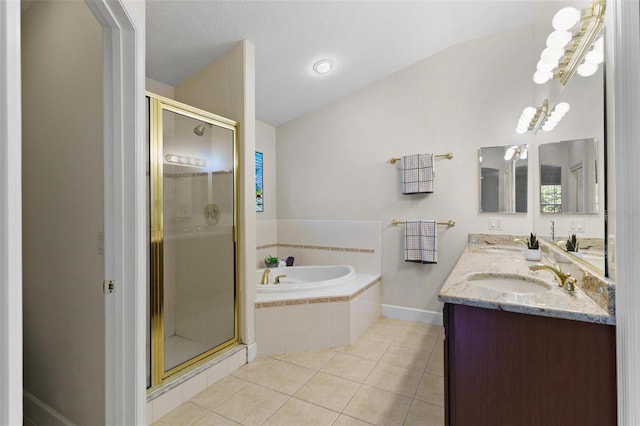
(163, 113, 235, 350)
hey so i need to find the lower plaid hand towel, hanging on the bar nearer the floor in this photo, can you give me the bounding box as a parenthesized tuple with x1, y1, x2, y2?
(404, 220, 438, 263)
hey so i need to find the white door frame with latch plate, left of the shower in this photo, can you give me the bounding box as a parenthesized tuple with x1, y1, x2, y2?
(86, 0, 148, 424)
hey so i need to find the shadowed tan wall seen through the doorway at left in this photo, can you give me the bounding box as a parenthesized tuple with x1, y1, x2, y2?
(22, 2, 105, 424)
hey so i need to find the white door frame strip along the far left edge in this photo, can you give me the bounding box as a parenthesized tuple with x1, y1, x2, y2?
(0, 0, 23, 424)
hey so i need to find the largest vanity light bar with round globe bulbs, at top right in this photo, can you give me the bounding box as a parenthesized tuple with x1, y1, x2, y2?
(533, 0, 606, 86)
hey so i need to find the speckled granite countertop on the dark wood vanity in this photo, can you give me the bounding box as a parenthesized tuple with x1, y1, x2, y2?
(438, 238, 615, 324)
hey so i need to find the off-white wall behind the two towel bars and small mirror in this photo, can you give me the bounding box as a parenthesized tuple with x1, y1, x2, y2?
(277, 27, 602, 311)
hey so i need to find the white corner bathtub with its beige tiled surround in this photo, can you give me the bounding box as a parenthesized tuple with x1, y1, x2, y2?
(255, 265, 381, 356)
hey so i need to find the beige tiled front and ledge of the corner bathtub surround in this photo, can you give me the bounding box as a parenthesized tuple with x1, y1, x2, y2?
(255, 274, 381, 356)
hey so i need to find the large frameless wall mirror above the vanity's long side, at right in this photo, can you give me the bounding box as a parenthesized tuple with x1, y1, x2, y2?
(523, 1, 615, 279)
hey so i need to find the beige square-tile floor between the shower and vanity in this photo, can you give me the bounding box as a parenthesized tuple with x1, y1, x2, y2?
(154, 318, 444, 426)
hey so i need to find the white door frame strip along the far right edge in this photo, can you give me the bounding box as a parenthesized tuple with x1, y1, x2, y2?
(607, 0, 640, 425)
